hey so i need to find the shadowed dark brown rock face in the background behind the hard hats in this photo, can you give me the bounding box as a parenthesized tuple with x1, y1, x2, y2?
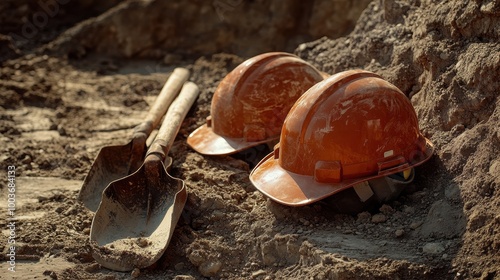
(44, 0, 370, 57)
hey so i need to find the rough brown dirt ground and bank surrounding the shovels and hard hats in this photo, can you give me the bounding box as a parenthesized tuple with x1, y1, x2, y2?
(0, 0, 500, 279)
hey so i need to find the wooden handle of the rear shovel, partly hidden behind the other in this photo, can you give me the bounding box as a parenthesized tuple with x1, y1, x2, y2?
(135, 68, 189, 136)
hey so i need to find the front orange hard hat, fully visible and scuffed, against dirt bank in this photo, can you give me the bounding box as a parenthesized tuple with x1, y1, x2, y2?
(250, 70, 434, 206)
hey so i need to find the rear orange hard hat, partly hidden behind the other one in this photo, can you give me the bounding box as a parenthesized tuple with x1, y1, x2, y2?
(187, 52, 323, 155)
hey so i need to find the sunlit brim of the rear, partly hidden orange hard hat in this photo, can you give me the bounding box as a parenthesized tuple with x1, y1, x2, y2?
(187, 124, 274, 156)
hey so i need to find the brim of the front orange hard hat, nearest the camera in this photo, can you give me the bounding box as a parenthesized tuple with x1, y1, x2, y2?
(250, 139, 434, 206)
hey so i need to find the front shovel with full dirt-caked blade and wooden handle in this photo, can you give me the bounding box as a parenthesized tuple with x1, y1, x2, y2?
(90, 82, 199, 271)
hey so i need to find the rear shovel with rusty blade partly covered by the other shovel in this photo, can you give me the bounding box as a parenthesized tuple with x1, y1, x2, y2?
(78, 68, 189, 212)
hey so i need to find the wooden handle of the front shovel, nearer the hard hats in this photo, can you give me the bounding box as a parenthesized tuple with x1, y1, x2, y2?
(146, 82, 199, 161)
